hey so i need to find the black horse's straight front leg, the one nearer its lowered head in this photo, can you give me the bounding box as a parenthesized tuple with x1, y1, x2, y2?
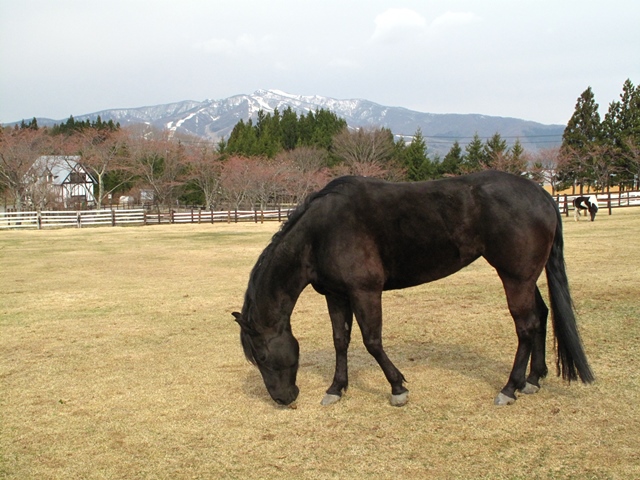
(320, 295, 353, 405)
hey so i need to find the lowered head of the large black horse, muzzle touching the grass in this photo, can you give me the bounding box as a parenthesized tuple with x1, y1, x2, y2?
(233, 312, 300, 405)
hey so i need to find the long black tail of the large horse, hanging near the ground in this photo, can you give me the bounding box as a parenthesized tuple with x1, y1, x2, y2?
(545, 207, 595, 383)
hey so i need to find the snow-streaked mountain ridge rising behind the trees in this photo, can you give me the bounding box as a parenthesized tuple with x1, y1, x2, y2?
(18, 90, 564, 155)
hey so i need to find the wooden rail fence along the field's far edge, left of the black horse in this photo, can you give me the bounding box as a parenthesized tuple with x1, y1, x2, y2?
(0, 208, 290, 230)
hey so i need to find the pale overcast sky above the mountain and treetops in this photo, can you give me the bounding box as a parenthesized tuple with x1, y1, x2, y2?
(0, 0, 640, 124)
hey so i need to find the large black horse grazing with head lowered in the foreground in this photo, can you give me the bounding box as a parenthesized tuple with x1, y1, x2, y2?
(233, 171, 594, 405)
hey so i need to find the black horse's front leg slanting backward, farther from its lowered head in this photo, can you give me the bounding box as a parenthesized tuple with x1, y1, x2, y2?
(351, 291, 409, 407)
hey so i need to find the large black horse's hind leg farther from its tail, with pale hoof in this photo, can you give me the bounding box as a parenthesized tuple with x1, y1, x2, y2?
(494, 275, 541, 405)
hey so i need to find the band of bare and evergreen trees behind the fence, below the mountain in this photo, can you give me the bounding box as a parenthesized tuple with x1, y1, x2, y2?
(0, 80, 640, 209)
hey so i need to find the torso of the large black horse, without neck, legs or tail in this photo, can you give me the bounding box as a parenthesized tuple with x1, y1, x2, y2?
(304, 171, 556, 289)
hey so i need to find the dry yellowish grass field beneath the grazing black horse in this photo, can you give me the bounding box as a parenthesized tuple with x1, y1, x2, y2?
(0, 208, 640, 479)
